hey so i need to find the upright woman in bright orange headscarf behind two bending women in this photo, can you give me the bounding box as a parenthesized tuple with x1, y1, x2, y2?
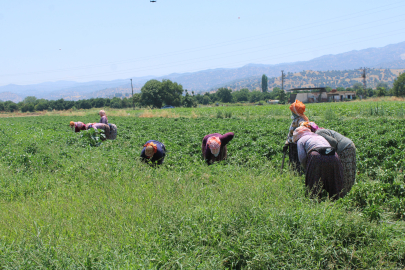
(283, 100, 309, 172)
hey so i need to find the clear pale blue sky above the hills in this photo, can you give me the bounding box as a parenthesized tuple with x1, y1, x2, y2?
(0, 0, 405, 86)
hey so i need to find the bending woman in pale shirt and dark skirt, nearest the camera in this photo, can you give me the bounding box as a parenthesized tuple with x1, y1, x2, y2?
(293, 126, 343, 199)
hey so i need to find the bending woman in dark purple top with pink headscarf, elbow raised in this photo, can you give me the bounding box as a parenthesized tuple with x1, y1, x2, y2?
(202, 132, 235, 165)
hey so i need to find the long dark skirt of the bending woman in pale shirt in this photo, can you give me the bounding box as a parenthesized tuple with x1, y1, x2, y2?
(305, 151, 343, 199)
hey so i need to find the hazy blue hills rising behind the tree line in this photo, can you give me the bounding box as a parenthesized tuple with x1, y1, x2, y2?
(0, 42, 405, 102)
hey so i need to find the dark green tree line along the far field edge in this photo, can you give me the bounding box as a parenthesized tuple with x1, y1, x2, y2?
(0, 73, 405, 112)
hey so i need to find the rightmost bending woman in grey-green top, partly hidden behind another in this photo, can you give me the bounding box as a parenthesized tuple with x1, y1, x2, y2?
(302, 122, 356, 196)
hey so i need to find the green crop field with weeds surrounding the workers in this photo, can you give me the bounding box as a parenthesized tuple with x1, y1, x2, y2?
(0, 101, 405, 269)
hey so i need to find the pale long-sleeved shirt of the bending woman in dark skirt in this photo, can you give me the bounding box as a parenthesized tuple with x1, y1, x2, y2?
(297, 133, 331, 168)
